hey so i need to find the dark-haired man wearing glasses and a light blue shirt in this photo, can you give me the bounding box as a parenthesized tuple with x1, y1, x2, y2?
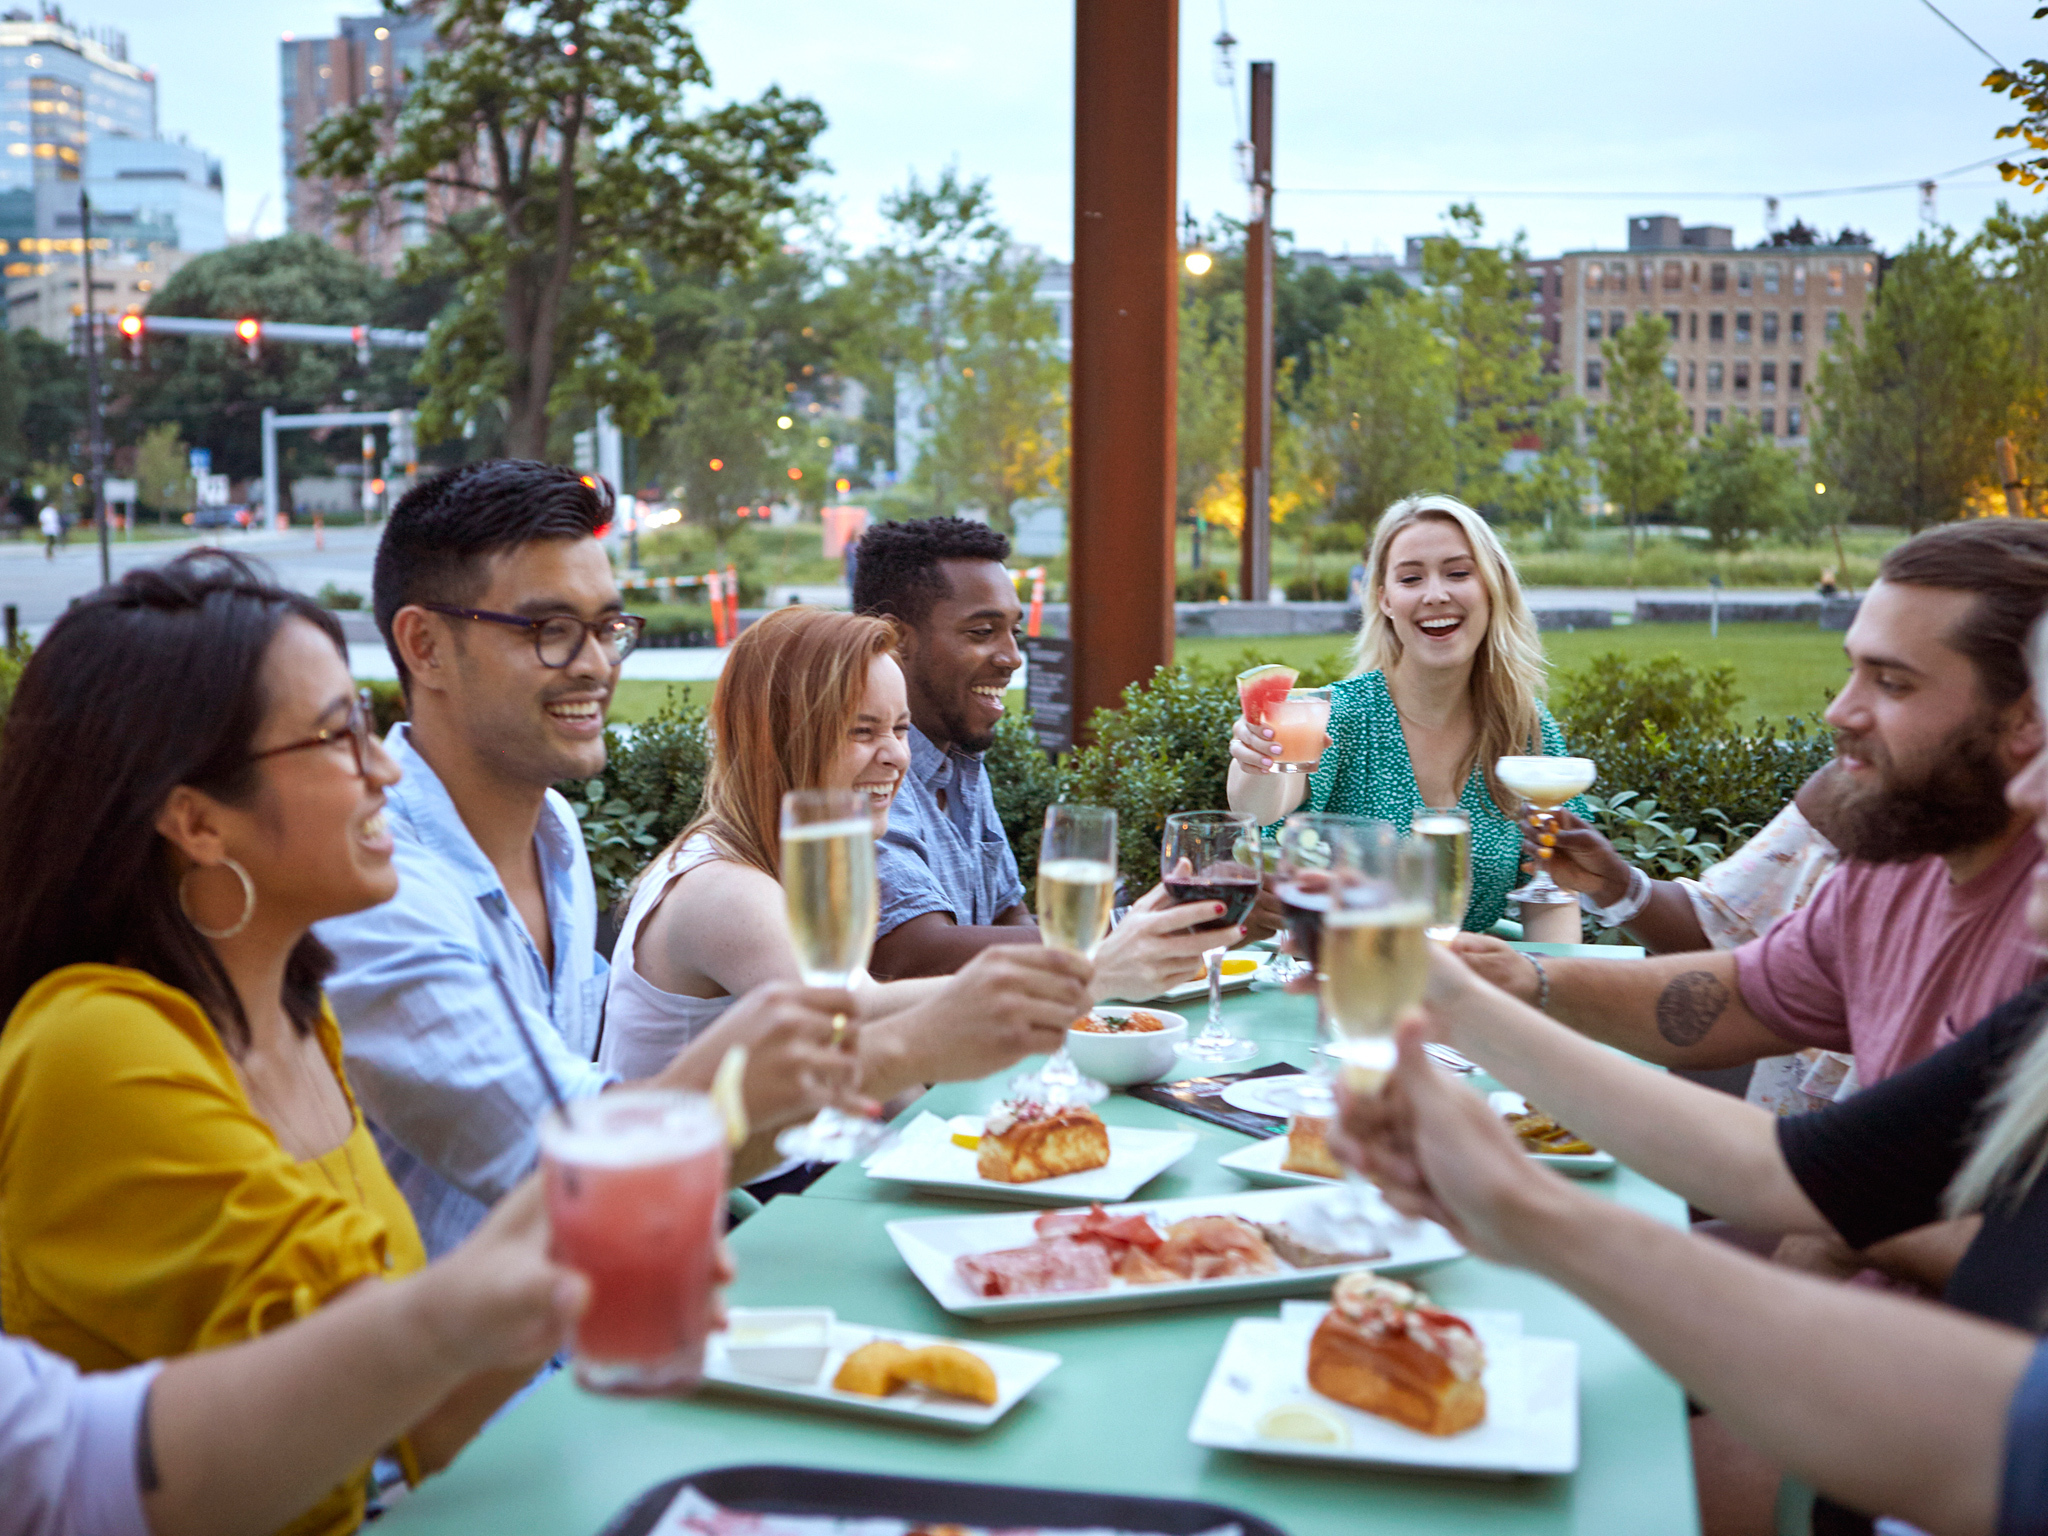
(317, 461, 854, 1255)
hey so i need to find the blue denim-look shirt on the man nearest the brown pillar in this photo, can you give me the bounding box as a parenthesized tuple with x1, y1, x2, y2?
(874, 725, 1024, 936)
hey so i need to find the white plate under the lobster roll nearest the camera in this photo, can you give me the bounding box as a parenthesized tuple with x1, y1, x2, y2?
(1188, 1303, 1579, 1477)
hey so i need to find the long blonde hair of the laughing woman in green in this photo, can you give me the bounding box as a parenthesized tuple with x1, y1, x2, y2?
(1352, 496, 1544, 815)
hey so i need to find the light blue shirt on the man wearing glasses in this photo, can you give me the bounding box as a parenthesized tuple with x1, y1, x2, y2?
(313, 725, 612, 1257)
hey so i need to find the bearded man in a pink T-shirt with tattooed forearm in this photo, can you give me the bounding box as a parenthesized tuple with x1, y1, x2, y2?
(1456, 518, 2048, 1085)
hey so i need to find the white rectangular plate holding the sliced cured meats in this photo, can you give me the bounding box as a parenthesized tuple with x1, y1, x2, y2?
(889, 1190, 1464, 1319)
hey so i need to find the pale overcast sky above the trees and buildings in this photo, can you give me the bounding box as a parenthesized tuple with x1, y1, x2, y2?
(68, 0, 2048, 256)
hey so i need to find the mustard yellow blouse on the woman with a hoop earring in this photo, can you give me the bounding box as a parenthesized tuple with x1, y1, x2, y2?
(0, 965, 426, 1536)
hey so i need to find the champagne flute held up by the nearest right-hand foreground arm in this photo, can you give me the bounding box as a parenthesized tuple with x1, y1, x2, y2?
(1319, 836, 1440, 1243)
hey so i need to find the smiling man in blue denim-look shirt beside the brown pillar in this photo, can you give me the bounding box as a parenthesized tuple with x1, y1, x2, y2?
(854, 518, 1223, 997)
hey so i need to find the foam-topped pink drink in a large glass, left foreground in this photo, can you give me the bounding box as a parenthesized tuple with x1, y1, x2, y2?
(541, 1090, 725, 1393)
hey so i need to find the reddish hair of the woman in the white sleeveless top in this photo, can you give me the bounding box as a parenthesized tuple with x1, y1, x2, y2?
(635, 606, 897, 883)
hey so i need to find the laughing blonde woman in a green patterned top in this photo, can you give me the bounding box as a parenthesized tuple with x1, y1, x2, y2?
(1229, 496, 1583, 944)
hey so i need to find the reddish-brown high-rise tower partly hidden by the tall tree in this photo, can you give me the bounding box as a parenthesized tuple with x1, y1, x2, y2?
(279, 14, 463, 272)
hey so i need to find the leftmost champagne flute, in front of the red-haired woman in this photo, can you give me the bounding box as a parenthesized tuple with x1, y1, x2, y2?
(776, 788, 883, 1163)
